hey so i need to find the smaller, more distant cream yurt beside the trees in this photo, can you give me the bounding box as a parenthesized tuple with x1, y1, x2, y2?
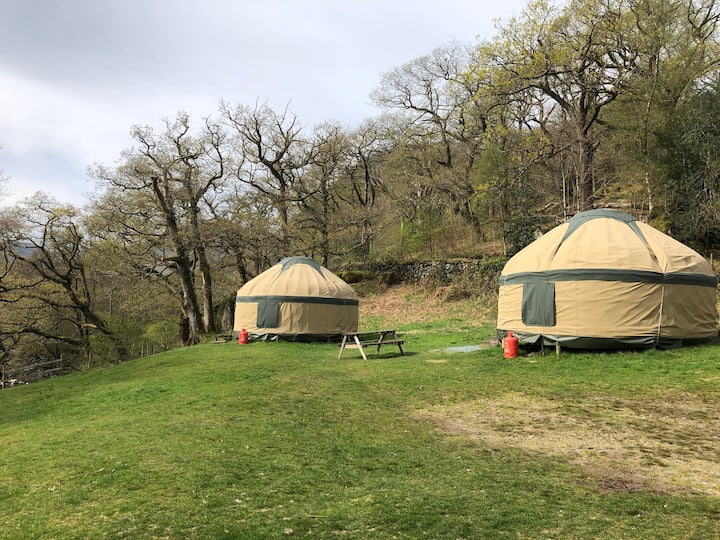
(234, 257, 359, 341)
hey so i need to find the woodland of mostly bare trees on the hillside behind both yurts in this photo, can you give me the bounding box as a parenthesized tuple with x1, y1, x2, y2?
(0, 0, 720, 369)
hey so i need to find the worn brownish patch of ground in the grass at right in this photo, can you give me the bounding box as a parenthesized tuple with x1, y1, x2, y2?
(419, 393, 720, 496)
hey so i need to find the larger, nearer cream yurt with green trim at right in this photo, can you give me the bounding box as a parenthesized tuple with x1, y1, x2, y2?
(497, 210, 718, 349)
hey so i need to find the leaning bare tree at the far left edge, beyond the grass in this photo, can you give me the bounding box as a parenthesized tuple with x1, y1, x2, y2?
(0, 193, 125, 358)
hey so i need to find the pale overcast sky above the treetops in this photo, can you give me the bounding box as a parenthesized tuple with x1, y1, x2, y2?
(0, 0, 527, 205)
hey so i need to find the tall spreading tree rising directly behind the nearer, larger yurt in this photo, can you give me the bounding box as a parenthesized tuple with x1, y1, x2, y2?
(479, 0, 638, 210)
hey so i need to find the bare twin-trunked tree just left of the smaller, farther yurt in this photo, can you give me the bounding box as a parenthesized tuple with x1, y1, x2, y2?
(92, 113, 226, 344)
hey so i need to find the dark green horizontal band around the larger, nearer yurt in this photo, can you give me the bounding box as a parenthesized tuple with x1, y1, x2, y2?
(500, 268, 718, 288)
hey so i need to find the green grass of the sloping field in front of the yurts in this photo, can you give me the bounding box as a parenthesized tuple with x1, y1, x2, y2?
(0, 321, 720, 539)
